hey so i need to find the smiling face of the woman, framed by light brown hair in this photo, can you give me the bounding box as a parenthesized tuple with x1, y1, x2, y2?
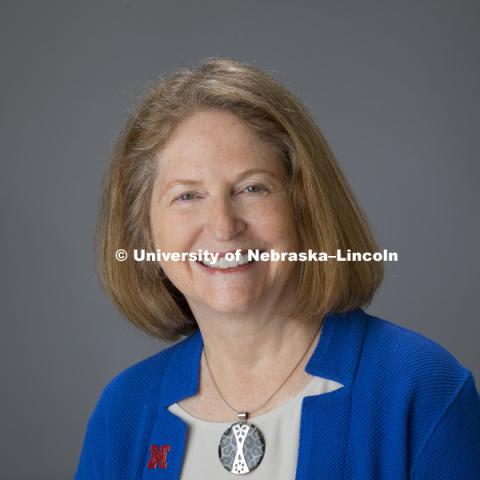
(150, 111, 298, 314)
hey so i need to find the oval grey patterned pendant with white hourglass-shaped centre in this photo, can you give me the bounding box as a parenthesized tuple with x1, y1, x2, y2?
(218, 422, 265, 475)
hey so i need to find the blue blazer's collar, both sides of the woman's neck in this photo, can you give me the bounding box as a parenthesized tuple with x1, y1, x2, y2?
(160, 308, 368, 407)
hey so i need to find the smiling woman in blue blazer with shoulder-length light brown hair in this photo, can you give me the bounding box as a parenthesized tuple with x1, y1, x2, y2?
(76, 59, 480, 480)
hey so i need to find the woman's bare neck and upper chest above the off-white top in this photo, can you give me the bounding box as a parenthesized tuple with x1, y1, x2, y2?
(181, 317, 321, 422)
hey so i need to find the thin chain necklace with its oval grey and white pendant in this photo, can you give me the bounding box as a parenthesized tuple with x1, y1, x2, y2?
(203, 322, 323, 475)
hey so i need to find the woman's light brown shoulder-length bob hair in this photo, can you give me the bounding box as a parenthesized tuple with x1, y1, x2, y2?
(97, 58, 383, 341)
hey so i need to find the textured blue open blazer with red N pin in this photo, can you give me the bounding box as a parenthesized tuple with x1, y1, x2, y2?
(75, 309, 480, 480)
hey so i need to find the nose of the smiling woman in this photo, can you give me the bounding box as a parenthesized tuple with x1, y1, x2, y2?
(208, 198, 245, 240)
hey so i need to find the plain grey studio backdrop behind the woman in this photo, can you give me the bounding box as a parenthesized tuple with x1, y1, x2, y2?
(0, 0, 480, 480)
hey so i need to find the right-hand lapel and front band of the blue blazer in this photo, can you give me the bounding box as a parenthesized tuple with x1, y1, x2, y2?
(296, 309, 366, 480)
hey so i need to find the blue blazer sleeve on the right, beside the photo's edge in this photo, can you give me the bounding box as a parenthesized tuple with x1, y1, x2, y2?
(412, 372, 480, 480)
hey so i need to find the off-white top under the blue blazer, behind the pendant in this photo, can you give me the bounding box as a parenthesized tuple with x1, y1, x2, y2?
(168, 376, 343, 480)
